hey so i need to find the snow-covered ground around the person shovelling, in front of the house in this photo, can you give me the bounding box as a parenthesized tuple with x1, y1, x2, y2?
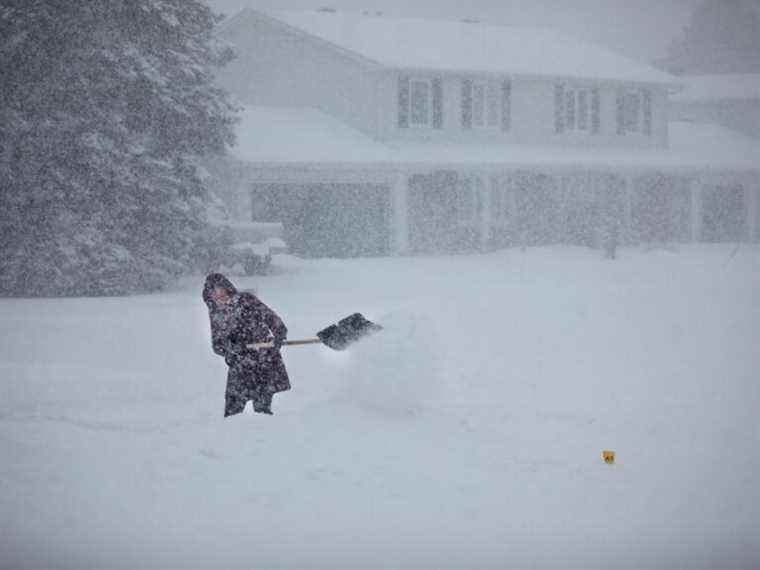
(0, 245, 760, 570)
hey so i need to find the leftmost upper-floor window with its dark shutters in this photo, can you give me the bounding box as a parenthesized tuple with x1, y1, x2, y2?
(398, 76, 443, 129)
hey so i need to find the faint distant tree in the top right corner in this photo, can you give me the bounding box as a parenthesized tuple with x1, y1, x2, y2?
(658, 0, 760, 75)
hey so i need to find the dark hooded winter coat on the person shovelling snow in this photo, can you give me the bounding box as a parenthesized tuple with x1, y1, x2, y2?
(203, 273, 290, 414)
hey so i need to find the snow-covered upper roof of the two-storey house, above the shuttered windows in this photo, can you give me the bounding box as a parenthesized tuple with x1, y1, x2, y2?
(232, 8, 679, 86)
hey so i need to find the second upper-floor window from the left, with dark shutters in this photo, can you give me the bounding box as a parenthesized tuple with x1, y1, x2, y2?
(461, 79, 512, 131)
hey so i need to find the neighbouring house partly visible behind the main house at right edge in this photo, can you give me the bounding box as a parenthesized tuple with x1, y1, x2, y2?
(670, 73, 760, 138)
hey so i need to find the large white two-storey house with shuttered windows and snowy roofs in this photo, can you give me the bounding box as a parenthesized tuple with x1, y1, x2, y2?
(211, 9, 760, 256)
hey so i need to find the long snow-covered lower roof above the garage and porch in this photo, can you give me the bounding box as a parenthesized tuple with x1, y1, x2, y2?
(232, 107, 760, 170)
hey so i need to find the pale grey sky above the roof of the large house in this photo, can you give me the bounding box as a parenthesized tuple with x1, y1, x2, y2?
(206, 0, 700, 60)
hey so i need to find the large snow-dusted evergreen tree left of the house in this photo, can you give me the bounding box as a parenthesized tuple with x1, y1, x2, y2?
(0, 0, 234, 296)
